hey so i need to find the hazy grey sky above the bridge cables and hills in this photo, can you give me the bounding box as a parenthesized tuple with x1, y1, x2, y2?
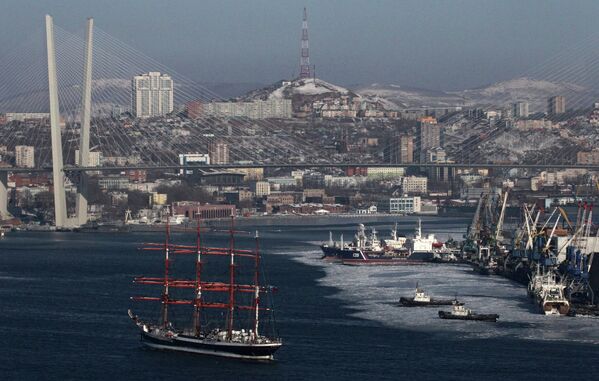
(0, 0, 599, 90)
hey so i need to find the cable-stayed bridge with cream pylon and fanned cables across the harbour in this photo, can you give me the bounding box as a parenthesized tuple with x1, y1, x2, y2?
(0, 16, 599, 227)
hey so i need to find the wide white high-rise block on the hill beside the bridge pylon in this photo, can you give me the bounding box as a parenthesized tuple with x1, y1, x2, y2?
(131, 71, 173, 118)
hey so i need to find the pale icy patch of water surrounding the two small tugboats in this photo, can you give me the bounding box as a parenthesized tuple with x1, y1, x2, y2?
(295, 249, 599, 344)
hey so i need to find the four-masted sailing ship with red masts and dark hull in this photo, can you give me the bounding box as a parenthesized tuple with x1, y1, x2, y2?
(129, 218, 282, 360)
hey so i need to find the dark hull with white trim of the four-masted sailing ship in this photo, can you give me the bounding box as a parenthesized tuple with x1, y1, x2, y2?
(141, 331, 282, 360)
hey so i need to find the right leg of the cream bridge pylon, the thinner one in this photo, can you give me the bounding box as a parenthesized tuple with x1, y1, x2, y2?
(76, 18, 94, 225)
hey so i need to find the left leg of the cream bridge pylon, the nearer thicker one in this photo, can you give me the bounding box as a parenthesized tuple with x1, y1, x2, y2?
(46, 15, 68, 227)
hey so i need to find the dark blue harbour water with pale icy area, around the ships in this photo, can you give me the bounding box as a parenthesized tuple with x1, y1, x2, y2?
(0, 217, 599, 380)
